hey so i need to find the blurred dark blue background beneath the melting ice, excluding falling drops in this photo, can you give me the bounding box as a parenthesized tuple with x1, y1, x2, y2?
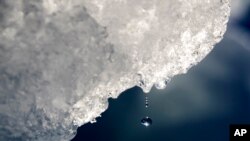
(72, 0, 250, 141)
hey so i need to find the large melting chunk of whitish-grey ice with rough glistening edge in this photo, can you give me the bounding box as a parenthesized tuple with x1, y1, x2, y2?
(0, 0, 229, 141)
